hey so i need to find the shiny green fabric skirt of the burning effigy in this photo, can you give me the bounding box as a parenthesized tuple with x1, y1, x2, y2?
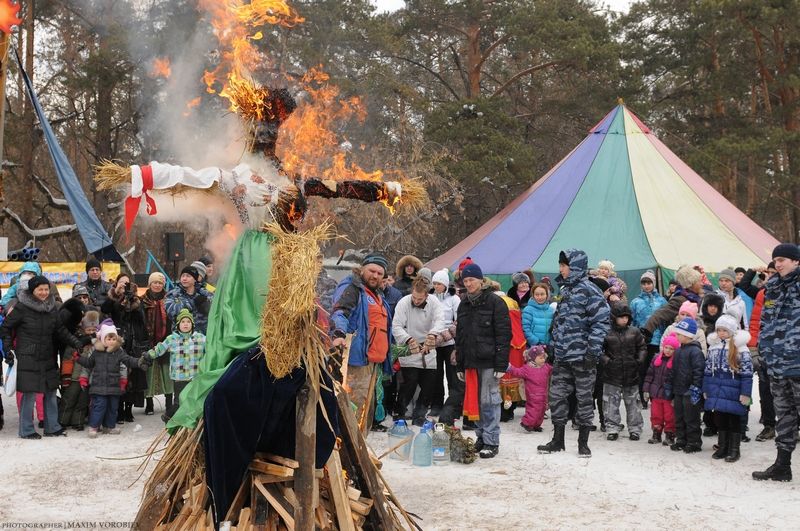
(167, 230, 273, 432)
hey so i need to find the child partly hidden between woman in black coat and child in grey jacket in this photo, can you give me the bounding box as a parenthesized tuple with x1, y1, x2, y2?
(58, 310, 100, 431)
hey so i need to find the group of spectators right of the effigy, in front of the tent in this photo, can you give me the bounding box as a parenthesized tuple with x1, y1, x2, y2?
(327, 243, 800, 481)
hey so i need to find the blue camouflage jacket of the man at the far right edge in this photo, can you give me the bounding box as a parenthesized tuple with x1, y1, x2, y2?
(758, 268, 800, 378)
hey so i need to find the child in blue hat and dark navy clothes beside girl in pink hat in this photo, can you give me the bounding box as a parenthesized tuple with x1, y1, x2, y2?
(668, 317, 706, 454)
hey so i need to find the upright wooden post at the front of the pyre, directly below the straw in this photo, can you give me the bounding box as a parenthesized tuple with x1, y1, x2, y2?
(294, 375, 319, 531)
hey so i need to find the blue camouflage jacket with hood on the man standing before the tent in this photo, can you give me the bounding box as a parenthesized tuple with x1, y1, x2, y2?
(551, 249, 611, 362)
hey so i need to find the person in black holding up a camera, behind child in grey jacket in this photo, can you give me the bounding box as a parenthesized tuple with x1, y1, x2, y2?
(100, 273, 150, 424)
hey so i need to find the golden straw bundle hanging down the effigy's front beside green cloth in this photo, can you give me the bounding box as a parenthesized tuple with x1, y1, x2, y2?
(261, 223, 331, 381)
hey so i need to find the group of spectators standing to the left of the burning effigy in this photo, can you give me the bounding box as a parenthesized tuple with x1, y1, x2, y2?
(0, 257, 214, 440)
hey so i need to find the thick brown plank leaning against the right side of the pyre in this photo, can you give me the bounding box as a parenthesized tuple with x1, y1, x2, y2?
(336, 392, 397, 529)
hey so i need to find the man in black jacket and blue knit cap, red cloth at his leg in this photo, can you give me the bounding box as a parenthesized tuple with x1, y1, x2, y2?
(456, 264, 511, 458)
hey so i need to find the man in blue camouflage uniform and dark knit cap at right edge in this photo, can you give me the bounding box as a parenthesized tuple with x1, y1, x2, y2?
(753, 243, 800, 481)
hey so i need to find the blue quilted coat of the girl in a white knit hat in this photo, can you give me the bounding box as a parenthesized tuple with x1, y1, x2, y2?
(703, 330, 753, 415)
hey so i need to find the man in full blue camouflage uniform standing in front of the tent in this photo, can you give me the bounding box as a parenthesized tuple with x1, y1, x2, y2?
(538, 249, 611, 457)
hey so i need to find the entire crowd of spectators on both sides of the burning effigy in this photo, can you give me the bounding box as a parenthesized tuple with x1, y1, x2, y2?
(0, 244, 800, 481)
